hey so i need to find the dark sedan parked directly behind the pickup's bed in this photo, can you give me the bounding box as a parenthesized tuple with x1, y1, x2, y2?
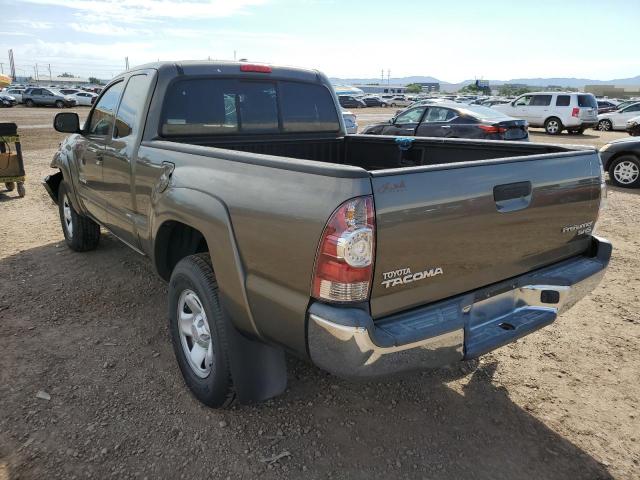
(362, 103, 529, 140)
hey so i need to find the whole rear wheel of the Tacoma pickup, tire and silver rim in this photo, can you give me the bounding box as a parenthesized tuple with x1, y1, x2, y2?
(169, 253, 236, 408)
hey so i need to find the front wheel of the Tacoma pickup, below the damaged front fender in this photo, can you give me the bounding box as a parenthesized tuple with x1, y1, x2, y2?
(58, 182, 100, 252)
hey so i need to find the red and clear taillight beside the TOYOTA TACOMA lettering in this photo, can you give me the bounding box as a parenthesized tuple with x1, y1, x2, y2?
(311, 195, 375, 302)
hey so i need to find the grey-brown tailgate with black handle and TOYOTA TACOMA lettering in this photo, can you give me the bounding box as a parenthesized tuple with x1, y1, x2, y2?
(371, 151, 600, 319)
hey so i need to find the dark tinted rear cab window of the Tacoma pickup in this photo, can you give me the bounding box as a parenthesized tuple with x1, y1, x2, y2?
(161, 78, 340, 135)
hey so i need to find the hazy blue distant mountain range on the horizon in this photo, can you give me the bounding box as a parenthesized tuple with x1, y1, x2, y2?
(331, 75, 640, 92)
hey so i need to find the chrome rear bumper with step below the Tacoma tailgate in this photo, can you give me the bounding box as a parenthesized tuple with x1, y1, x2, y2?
(307, 237, 612, 378)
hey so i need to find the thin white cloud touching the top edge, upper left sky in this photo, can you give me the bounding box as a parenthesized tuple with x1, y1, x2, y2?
(20, 0, 268, 21)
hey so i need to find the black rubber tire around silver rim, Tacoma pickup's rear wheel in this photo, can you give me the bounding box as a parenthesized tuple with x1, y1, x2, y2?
(169, 253, 236, 408)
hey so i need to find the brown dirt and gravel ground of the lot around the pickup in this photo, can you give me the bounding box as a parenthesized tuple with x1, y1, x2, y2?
(0, 107, 640, 480)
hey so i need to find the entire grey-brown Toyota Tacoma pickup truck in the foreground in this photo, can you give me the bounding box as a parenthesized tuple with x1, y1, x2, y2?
(44, 62, 611, 407)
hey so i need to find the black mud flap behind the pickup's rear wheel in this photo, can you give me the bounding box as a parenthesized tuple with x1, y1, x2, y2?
(227, 317, 287, 405)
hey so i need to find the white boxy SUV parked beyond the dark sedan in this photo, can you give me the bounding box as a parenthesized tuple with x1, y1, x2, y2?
(492, 92, 598, 135)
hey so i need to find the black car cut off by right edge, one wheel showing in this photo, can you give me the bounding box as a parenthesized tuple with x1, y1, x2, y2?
(600, 137, 640, 188)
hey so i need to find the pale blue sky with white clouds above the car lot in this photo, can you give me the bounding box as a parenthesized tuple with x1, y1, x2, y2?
(0, 0, 640, 82)
